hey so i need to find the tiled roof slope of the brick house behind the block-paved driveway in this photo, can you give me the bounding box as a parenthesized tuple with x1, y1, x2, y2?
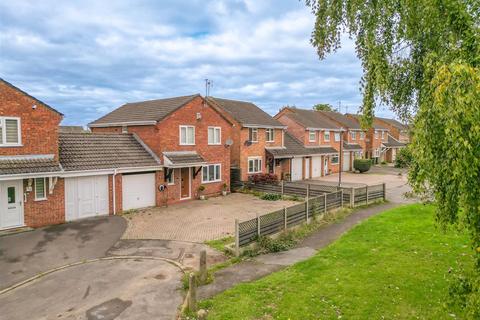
(89, 94, 200, 127)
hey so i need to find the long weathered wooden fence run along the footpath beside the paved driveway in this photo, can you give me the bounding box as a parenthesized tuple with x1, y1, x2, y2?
(235, 190, 343, 255)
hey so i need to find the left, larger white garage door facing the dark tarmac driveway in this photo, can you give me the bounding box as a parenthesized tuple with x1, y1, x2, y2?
(65, 175, 108, 221)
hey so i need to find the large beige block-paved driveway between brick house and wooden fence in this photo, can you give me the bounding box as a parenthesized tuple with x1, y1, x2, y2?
(123, 193, 297, 242)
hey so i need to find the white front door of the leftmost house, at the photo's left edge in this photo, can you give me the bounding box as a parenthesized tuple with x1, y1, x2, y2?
(0, 180, 23, 229)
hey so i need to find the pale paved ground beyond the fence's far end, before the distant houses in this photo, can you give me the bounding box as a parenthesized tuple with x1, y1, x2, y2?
(307, 165, 416, 203)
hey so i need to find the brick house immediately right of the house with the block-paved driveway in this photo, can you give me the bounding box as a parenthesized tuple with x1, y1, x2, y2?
(208, 97, 291, 181)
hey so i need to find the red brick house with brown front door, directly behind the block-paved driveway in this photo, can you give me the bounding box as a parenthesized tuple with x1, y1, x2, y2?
(89, 94, 234, 203)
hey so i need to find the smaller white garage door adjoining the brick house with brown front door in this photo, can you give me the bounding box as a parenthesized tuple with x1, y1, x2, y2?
(122, 173, 155, 210)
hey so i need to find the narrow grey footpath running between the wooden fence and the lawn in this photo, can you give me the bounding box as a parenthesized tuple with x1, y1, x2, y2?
(198, 203, 399, 299)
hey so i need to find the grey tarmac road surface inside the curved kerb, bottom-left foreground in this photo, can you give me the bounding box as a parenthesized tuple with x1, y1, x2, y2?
(0, 259, 183, 320)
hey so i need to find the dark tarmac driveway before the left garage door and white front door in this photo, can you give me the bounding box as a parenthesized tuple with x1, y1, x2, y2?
(0, 216, 127, 289)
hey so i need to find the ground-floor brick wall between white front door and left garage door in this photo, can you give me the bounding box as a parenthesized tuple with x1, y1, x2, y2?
(23, 178, 65, 228)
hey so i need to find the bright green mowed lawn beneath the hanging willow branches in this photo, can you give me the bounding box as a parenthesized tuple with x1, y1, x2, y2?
(201, 204, 471, 320)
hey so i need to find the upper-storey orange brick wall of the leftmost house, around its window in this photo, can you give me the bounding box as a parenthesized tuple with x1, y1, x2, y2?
(0, 81, 62, 159)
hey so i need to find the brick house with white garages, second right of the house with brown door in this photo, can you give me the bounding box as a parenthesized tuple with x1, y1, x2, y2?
(275, 107, 362, 179)
